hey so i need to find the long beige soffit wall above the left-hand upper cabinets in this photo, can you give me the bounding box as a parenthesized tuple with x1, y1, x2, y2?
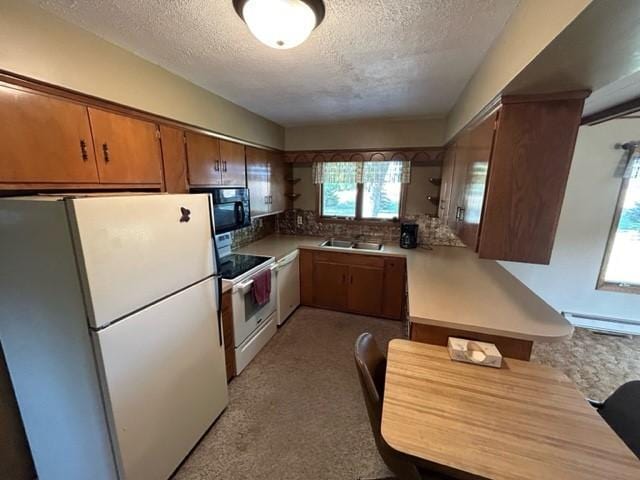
(0, 0, 284, 148)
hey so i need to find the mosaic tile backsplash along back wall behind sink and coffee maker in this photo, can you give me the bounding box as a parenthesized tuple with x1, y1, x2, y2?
(276, 209, 464, 246)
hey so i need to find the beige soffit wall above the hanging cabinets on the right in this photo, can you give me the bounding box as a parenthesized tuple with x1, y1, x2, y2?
(445, 0, 591, 140)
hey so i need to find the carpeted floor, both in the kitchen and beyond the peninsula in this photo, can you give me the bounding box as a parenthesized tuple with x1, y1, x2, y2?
(175, 307, 640, 480)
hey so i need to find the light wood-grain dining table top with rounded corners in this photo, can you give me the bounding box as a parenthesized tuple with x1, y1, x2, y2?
(382, 339, 640, 480)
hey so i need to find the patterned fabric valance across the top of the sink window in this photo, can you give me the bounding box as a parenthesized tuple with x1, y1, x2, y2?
(313, 161, 411, 184)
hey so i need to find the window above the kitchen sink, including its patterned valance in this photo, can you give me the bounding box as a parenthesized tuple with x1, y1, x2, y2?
(313, 161, 411, 220)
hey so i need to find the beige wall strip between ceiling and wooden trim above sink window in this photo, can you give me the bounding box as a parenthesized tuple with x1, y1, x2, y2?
(285, 119, 445, 150)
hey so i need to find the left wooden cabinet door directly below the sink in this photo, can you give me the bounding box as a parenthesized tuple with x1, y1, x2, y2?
(313, 259, 349, 310)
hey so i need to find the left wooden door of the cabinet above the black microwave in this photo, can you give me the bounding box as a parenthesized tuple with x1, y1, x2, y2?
(186, 132, 222, 186)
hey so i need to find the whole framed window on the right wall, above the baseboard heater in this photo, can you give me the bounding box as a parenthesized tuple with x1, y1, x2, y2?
(598, 149, 640, 293)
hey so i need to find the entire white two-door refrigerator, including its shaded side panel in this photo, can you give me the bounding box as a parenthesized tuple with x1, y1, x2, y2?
(0, 194, 228, 480)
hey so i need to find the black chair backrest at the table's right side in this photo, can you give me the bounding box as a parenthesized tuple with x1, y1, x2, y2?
(598, 380, 640, 458)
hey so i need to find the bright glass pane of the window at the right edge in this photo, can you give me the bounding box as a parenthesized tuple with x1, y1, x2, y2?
(604, 178, 640, 286)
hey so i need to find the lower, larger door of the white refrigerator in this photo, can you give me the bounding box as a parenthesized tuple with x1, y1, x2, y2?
(93, 279, 228, 480)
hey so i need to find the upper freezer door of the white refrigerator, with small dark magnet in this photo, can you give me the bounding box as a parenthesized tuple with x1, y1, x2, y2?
(67, 194, 215, 328)
